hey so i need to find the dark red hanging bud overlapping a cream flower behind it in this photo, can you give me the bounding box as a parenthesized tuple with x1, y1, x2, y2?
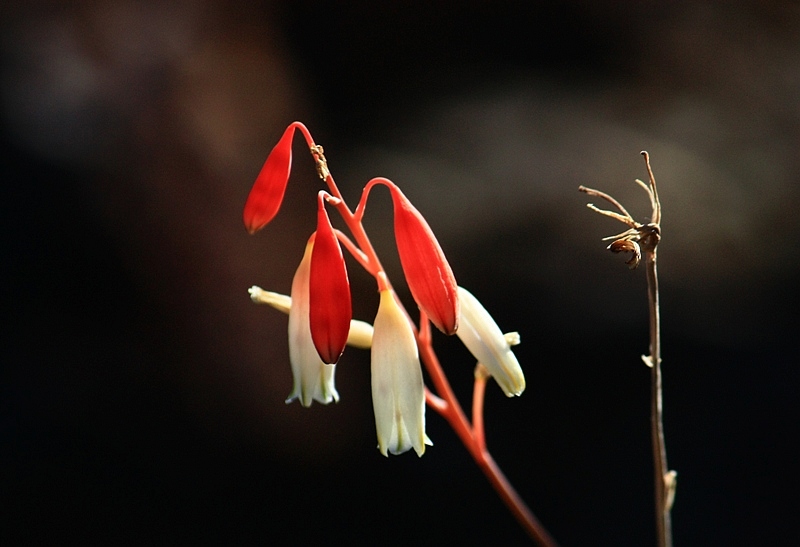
(309, 192, 353, 363)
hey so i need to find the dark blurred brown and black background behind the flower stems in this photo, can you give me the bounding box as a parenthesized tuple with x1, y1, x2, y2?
(0, 0, 800, 546)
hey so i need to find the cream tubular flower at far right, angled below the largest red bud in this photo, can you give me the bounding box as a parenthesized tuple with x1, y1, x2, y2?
(456, 287, 525, 397)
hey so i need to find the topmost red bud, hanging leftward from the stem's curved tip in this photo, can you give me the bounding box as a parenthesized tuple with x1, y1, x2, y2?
(243, 124, 295, 234)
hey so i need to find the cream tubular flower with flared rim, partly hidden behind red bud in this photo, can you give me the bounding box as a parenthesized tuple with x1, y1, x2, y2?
(286, 240, 339, 407)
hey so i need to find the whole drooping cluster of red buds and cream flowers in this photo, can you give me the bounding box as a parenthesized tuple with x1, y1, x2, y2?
(243, 122, 525, 456)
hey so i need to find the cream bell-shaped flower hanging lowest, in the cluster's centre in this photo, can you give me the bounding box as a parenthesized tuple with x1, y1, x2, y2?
(371, 289, 432, 456)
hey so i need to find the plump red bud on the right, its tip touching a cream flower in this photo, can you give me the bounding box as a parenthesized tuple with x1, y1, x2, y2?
(389, 185, 458, 334)
